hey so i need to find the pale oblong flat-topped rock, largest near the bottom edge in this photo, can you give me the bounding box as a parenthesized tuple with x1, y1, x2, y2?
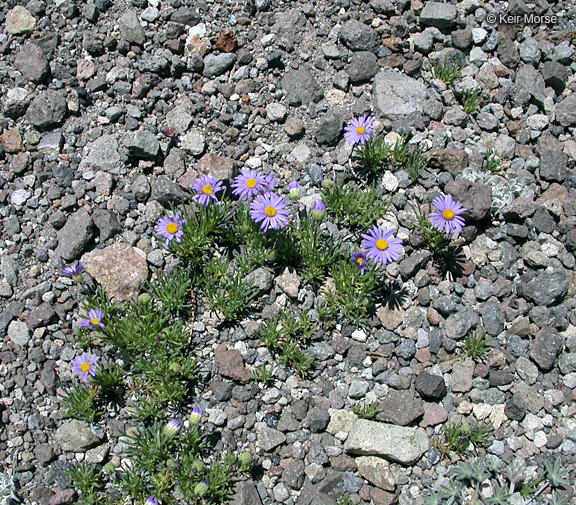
(344, 419, 428, 465)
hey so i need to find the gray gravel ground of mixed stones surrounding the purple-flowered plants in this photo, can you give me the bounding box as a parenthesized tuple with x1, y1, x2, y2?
(0, 0, 576, 505)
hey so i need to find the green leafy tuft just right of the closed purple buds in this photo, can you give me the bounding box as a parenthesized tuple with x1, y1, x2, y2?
(322, 182, 391, 228)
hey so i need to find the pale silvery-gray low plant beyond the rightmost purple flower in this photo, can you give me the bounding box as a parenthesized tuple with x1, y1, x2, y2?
(457, 166, 536, 214)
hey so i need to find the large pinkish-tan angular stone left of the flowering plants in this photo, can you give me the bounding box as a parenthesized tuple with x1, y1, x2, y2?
(82, 244, 148, 302)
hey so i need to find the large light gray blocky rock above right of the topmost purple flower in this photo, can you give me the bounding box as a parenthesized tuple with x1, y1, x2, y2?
(372, 68, 428, 126)
